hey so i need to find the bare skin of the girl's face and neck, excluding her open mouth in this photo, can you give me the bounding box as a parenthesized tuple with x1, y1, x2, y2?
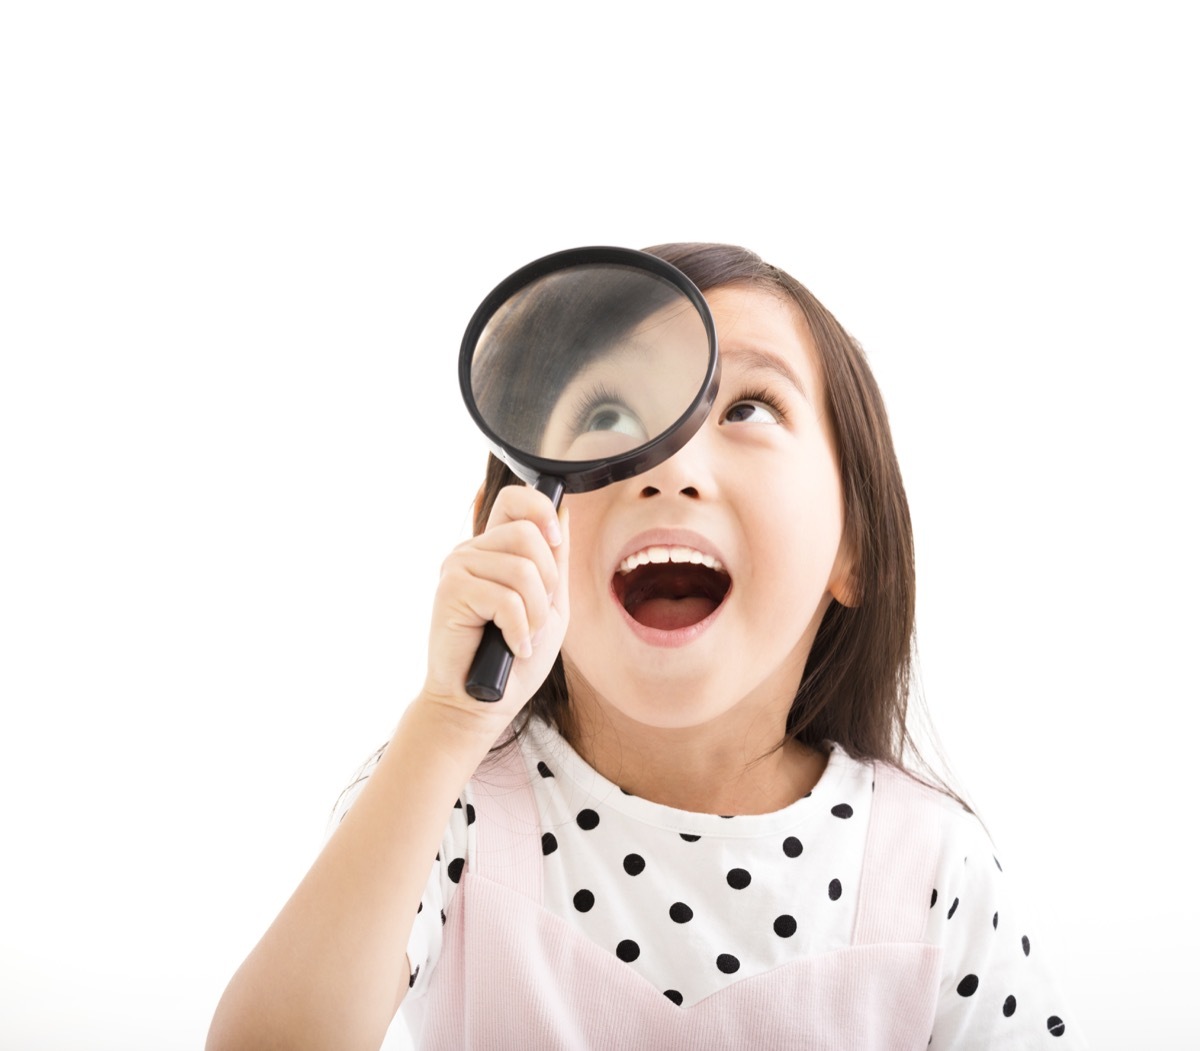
(563, 287, 851, 813)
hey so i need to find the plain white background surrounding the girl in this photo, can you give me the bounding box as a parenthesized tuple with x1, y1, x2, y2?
(0, 0, 1200, 1051)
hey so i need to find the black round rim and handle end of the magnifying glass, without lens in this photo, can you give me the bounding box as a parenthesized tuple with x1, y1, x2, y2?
(458, 245, 721, 701)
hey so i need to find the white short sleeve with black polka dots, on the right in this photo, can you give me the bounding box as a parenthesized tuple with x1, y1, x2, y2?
(926, 804, 1087, 1051)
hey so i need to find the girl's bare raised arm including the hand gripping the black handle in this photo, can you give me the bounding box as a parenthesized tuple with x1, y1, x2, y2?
(206, 487, 568, 1051)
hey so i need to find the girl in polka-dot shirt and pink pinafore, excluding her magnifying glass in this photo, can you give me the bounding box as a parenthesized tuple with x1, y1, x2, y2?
(209, 245, 1082, 1051)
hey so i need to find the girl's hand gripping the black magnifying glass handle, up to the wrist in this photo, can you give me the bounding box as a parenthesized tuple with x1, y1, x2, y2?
(424, 485, 569, 734)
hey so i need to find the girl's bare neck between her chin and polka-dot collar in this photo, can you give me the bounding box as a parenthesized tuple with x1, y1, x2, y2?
(565, 691, 827, 816)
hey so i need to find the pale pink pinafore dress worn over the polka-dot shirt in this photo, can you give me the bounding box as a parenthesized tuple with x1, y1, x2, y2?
(403, 747, 942, 1051)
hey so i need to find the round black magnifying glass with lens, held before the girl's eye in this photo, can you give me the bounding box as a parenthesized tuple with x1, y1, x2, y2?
(458, 247, 720, 701)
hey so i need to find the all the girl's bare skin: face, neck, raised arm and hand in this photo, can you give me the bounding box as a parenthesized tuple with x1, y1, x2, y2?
(206, 279, 853, 1051)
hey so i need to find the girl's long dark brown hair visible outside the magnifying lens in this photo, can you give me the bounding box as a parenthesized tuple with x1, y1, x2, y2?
(474, 244, 925, 768)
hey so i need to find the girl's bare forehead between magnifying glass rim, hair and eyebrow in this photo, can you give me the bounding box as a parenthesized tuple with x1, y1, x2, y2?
(704, 284, 824, 406)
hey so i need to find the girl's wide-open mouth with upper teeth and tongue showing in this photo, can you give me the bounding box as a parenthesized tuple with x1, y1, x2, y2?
(612, 546, 731, 631)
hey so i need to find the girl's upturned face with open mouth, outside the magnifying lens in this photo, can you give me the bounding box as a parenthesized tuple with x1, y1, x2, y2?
(563, 286, 853, 733)
